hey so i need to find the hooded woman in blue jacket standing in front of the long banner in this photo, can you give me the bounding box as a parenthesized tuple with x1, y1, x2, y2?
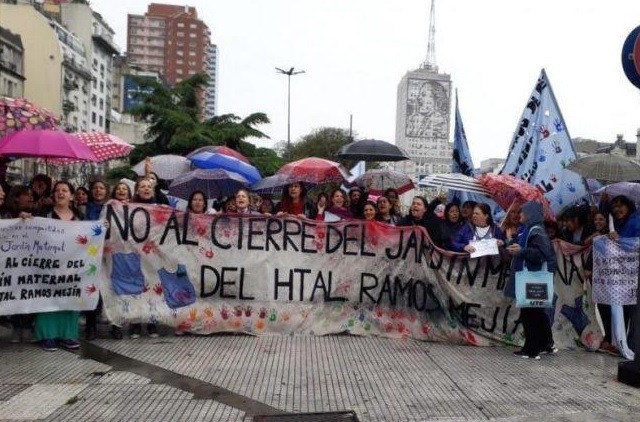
(504, 201, 558, 360)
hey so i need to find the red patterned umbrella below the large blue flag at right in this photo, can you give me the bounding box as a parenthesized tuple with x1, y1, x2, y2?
(478, 174, 555, 220)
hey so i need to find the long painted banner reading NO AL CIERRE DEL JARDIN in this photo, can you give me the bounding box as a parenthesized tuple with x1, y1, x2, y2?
(102, 202, 602, 348)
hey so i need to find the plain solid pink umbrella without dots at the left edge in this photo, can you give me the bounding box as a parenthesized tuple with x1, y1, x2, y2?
(0, 130, 98, 161)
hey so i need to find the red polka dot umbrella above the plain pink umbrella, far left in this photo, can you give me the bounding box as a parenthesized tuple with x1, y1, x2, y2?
(0, 96, 60, 138)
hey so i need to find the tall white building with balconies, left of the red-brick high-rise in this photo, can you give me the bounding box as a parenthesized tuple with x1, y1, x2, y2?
(61, 3, 119, 132)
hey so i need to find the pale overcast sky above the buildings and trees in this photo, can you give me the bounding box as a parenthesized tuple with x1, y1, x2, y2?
(91, 0, 640, 166)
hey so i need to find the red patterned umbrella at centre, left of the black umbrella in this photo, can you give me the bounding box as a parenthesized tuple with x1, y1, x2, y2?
(276, 157, 349, 184)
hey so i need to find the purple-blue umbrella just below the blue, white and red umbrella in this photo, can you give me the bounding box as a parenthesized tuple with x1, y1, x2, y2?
(169, 169, 249, 199)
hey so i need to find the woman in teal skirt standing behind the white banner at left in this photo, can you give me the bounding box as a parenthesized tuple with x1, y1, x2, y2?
(34, 181, 81, 352)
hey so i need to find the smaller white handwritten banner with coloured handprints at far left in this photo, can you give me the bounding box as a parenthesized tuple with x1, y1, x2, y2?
(0, 218, 105, 315)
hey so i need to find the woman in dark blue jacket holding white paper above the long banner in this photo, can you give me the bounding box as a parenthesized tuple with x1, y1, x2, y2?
(451, 202, 505, 257)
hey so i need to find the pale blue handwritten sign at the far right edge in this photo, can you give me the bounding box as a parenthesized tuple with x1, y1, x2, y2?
(592, 236, 638, 305)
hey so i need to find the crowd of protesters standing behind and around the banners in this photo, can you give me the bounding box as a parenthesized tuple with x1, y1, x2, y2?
(0, 166, 640, 359)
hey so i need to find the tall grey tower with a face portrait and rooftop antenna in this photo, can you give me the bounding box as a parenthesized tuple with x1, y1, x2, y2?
(396, 0, 452, 195)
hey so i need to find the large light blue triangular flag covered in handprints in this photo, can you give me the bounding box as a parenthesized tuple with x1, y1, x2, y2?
(500, 69, 588, 214)
